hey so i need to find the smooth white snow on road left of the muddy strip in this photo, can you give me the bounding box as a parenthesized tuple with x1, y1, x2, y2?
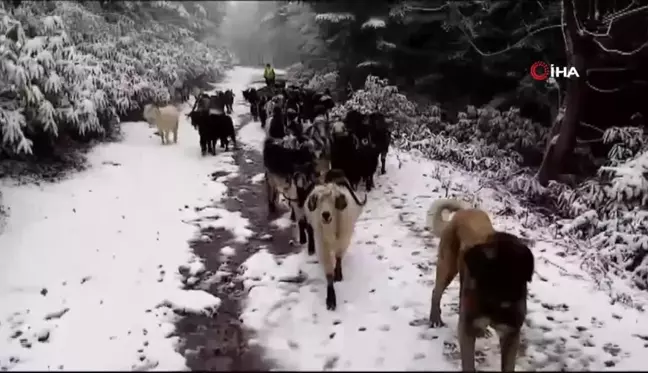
(0, 68, 251, 370)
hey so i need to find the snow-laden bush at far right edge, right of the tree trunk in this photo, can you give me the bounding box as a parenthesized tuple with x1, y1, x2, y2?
(558, 127, 648, 289)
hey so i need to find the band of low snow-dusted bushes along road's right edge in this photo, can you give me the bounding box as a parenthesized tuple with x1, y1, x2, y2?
(398, 94, 648, 289)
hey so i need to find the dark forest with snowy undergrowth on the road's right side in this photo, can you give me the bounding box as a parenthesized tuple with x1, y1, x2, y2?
(264, 0, 648, 288)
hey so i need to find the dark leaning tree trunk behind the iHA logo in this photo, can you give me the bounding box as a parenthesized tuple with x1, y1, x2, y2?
(537, 0, 587, 186)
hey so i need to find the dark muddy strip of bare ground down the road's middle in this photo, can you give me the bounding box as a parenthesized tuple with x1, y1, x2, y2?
(176, 115, 300, 371)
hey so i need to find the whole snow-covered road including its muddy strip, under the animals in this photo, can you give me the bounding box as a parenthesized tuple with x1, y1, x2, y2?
(0, 68, 648, 370)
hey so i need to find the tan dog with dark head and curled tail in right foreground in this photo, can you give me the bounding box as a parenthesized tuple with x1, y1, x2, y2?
(427, 199, 534, 371)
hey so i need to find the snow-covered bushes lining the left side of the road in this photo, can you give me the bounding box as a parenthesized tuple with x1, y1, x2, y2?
(0, 1, 233, 153)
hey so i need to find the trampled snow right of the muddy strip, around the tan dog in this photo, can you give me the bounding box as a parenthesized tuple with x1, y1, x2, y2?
(240, 72, 648, 371)
